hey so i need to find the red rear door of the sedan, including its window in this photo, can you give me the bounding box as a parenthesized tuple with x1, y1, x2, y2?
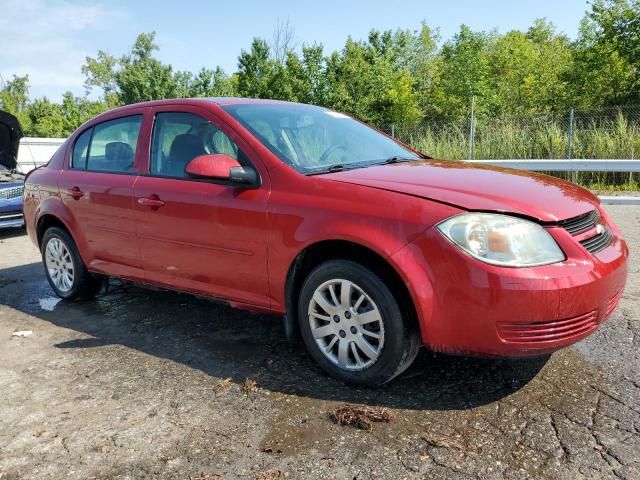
(58, 111, 143, 278)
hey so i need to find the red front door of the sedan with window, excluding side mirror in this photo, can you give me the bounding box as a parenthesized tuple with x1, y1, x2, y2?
(134, 107, 269, 307)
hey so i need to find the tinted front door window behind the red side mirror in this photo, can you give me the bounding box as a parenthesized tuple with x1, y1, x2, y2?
(151, 112, 248, 178)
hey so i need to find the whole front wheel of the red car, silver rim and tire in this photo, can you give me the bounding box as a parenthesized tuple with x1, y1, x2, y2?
(298, 260, 420, 386)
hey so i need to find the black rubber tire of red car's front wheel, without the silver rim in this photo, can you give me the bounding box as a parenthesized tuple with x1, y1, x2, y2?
(298, 260, 421, 387)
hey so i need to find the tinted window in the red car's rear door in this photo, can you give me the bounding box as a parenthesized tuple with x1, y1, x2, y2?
(87, 115, 142, 172)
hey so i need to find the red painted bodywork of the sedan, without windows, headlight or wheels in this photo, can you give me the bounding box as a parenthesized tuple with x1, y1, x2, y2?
(24, 99, 628, 355)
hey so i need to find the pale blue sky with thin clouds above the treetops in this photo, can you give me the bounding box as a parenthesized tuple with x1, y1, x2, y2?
(0, 0, 588, 101)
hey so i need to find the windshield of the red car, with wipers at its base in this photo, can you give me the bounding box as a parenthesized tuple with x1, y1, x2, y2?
(224, 103, 420, 174)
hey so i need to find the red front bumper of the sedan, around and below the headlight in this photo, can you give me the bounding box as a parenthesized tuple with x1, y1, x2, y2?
(393, 209, 628, 356)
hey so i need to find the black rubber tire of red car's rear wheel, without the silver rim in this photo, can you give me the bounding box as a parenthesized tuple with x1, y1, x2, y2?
(40, 227, 104, 301)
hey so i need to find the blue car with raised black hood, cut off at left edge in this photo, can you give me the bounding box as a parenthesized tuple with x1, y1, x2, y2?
(0, 111, 24, 229)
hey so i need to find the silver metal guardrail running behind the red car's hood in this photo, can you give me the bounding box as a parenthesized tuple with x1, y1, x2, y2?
(465, 159, 640, 172)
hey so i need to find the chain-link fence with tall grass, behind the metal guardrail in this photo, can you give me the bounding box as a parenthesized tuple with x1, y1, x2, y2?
(384, 106, 640, 189)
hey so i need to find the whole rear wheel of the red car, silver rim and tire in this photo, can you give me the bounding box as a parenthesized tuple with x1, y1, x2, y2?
(41, 227, 103, 300)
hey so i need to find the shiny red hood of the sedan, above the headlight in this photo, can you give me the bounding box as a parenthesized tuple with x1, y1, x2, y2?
(320, 160, 599, 222)
